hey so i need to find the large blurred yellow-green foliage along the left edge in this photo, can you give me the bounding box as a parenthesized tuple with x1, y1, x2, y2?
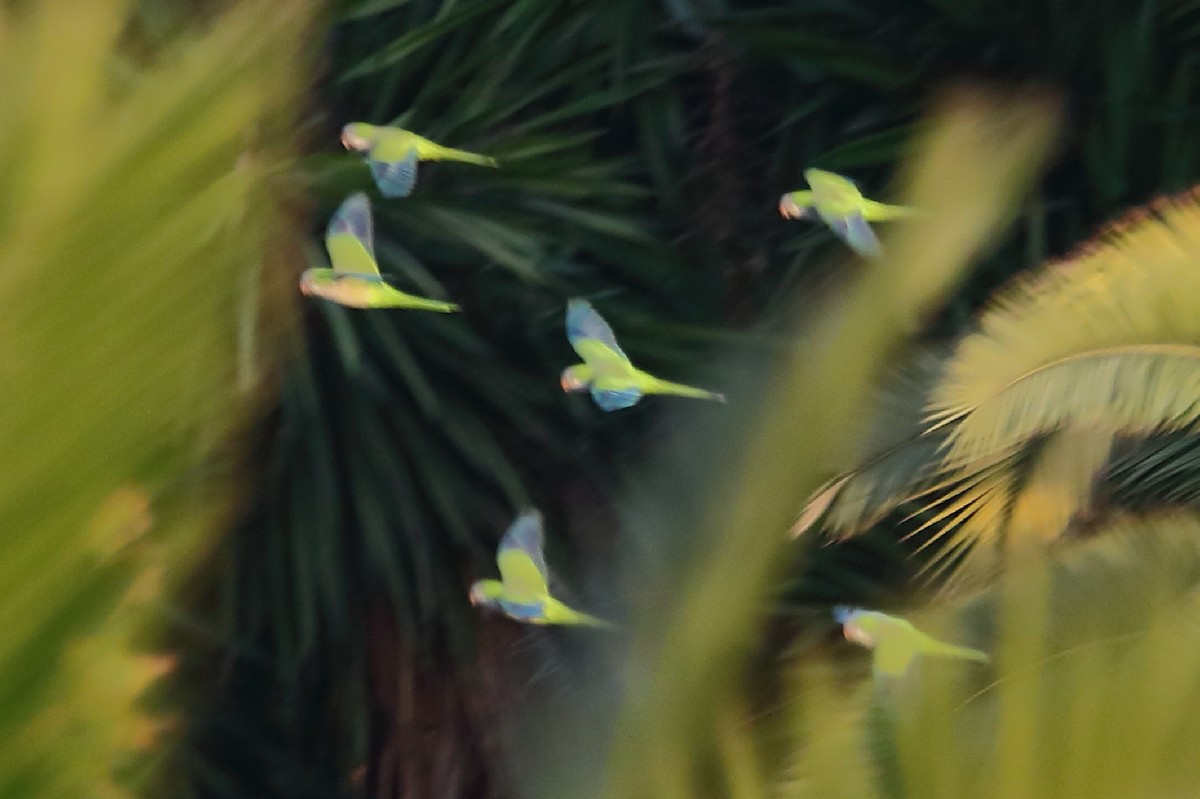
(0, 0, 308, 797)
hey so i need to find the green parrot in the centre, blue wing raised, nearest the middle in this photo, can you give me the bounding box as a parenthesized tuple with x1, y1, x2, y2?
(560, 299, 725, 410)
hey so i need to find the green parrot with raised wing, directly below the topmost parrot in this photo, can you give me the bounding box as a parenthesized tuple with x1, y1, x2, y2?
(300, 192, 458, 313)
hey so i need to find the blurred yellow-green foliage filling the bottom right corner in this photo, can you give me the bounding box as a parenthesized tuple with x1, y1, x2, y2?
(777, 516, 1200, 798)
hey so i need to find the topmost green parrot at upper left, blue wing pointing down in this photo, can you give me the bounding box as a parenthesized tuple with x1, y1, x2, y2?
(342, 122, 497, 197)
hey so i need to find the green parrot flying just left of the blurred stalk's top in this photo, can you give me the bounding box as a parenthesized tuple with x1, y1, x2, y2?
(779, 169, 917, 257)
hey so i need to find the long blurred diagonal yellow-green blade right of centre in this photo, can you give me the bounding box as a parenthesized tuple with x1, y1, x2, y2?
(542, 85, 1055, 799)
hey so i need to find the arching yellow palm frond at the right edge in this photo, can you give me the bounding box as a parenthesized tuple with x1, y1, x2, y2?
(929, 196, 1200, 463)
